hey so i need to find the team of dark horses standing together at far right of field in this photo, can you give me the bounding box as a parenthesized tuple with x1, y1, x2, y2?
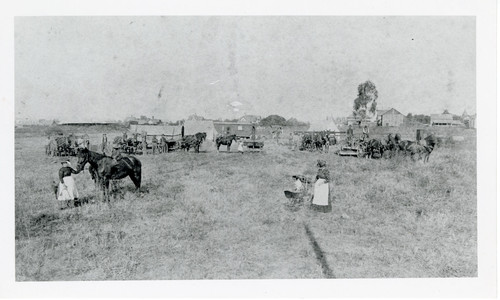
(360, 133, 437, 162)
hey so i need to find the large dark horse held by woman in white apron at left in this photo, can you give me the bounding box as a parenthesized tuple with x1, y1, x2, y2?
(77, 149, 141, 201)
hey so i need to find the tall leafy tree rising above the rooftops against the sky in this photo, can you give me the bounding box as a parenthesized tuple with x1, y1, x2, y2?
(353, 80, 378, 120)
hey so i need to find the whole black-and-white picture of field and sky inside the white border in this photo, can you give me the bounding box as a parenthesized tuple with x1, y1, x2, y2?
(1, 0, 496, 298)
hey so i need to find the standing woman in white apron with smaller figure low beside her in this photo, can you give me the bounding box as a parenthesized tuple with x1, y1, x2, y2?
(292, 160, 332, 213)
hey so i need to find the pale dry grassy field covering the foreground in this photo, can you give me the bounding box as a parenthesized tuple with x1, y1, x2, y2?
(15, 125, 477, 281)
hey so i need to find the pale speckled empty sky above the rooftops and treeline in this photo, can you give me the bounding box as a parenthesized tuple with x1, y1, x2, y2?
(14, 16, 476, 122)
